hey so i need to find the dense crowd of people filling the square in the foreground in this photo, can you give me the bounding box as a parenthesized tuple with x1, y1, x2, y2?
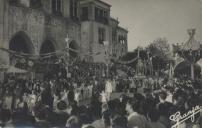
(0, 61, 202, 128)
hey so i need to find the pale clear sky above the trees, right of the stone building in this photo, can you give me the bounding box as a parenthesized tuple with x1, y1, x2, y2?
(102, 0, 202, 51)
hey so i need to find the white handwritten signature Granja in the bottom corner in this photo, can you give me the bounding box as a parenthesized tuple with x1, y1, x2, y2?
(170, 106, 202, 128)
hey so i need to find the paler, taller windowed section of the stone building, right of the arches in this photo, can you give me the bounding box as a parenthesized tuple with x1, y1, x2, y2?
(80, 0, 128, 62)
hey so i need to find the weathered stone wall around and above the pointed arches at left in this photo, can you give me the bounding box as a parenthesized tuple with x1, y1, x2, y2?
(0, 1, 81, 64)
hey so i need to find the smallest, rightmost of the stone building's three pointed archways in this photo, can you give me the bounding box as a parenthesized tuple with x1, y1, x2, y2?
(69, 40, 79, 58)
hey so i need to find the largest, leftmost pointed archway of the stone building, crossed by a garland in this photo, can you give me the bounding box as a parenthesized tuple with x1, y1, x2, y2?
(9, 32, 34, 69)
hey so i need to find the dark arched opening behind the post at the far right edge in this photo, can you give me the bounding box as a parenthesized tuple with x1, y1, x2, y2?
(174, 61, 201, 78)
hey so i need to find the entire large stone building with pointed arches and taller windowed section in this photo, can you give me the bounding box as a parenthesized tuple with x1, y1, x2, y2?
(0, 0, 128, 70)
